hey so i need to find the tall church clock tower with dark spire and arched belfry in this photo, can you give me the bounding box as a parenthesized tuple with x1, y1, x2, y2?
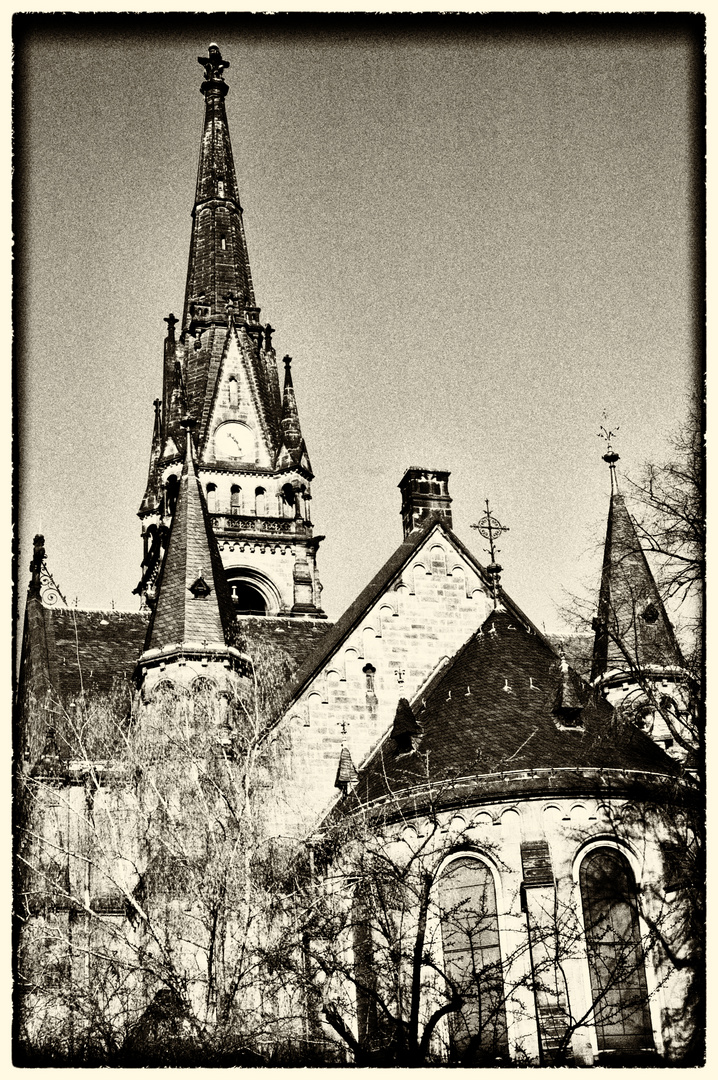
(136, 44, 324, 618)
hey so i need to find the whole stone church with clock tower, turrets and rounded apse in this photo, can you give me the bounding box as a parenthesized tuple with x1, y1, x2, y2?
(16, 44, 695, 1065)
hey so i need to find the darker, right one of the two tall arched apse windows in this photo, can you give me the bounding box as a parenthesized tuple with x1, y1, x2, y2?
(580, 848, 653, 1051)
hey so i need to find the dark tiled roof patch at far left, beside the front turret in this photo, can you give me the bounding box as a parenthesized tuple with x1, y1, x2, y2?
(44, 608, 148, 701)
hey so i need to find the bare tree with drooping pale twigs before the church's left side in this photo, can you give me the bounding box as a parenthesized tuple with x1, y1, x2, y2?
(17, 650, 299, 1064)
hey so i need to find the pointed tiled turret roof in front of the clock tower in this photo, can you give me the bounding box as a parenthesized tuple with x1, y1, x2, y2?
(147, 429, 235, 649)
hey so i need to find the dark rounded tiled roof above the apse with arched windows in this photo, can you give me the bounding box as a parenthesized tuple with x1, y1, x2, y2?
(356, 611, 679, 801)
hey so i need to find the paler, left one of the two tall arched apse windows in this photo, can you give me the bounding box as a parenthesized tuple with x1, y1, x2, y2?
(438, 858, 507, 1065)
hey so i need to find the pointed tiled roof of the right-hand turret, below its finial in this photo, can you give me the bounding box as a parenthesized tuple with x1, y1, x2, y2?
(591, 491, 683, 679)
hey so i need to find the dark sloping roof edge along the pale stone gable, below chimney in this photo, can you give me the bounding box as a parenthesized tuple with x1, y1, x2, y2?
(276, 516, 538, 707)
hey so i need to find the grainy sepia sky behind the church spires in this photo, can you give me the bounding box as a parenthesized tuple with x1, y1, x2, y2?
(14, 13, 703, 631)
